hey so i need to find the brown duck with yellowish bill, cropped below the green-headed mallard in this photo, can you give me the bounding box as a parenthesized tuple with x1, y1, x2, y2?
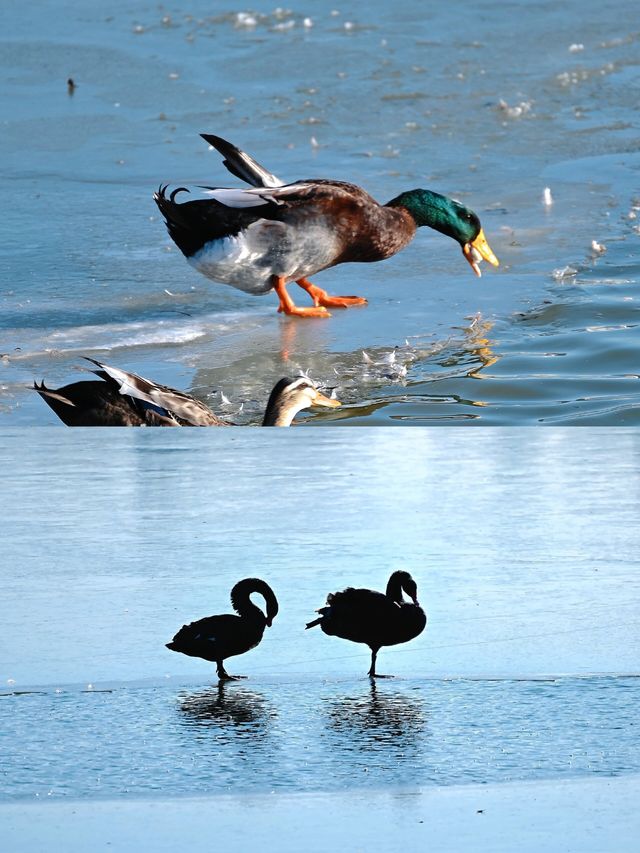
(33, 358, 340, 426)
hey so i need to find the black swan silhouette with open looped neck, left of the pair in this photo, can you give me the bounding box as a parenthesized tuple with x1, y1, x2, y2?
(166, 578, 278, 681)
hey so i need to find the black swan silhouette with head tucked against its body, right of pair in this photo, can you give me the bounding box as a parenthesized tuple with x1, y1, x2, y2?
(306, 571, 427, 678)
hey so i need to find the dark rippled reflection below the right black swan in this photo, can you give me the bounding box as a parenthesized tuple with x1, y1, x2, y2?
(327, 681, 429, 768)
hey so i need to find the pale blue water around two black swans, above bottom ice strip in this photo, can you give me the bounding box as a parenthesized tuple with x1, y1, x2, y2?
(0, 428, 640, 799)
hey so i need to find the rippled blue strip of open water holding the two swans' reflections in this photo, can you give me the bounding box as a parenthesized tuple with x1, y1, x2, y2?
(0, 677, 640, 800)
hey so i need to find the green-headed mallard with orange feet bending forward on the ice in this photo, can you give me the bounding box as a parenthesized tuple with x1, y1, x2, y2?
(154, 133, 498, 317)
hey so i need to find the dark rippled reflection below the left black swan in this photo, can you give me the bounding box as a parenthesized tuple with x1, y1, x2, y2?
(178, 681, 276, 739)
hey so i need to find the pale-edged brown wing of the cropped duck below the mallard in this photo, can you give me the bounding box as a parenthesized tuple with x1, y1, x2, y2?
(87, 358, 225, 426)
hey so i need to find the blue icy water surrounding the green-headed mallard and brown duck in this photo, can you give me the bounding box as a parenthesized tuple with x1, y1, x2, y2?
(0, 0, 640, 426)
